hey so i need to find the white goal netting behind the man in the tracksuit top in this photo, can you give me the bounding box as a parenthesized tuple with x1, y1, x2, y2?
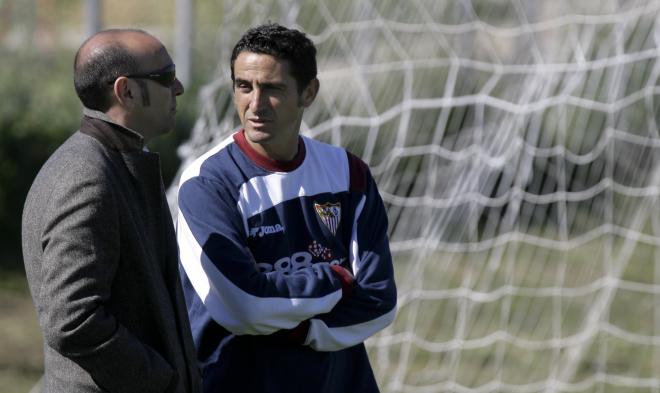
(170, 0, 660, 392)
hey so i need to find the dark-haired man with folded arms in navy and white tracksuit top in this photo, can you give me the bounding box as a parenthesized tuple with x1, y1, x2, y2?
(177, 24, 396, 393)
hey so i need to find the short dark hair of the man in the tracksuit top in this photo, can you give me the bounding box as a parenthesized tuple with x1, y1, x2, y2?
(231, 23, 316, 93)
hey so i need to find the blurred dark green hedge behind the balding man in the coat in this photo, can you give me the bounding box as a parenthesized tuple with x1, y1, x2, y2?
(0, 49, 196, 271)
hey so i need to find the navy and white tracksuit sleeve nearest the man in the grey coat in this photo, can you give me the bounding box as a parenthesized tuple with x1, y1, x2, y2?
(177, 176, 342, 335)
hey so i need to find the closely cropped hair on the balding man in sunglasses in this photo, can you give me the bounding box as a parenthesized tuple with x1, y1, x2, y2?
(73, 30, 146, 112)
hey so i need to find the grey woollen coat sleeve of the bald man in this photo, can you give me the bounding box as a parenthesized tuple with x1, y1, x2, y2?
(35, 163, 176, 393)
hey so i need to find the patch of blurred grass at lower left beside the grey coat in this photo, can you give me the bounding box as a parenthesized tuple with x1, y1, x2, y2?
(0, 272, 43, 393)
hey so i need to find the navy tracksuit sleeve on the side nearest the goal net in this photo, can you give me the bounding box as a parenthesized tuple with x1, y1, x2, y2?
(305, 154, 396, 351)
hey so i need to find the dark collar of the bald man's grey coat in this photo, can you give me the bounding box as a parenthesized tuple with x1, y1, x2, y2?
(80, 108, 145, 152)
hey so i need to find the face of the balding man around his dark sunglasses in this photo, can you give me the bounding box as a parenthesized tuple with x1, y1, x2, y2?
(133, 50, 183, 139)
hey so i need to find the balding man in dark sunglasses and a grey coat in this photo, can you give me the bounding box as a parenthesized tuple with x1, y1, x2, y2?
(22, 30, 200, 393)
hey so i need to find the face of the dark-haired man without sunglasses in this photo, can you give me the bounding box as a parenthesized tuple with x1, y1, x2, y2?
(234, 52, 318, 161)
